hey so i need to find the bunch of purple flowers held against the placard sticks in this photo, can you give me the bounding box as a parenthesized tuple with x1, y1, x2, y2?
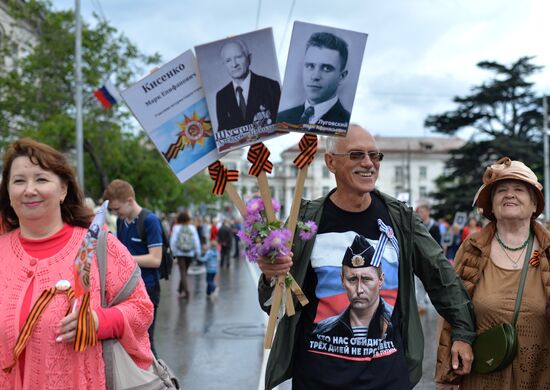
(238, 198, 317, 262)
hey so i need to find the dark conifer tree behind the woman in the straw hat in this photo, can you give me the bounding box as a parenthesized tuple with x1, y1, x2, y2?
(425, 57, 543, 216)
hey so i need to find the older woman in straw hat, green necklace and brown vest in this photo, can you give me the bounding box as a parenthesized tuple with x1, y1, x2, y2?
(436, 157, 550, 390)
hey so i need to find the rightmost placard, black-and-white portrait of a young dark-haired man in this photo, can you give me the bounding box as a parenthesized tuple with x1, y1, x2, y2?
(277, 22, 367, 136)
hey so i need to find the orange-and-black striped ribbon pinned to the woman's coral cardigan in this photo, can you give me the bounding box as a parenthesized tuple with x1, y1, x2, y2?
(2, 286, 75, 374)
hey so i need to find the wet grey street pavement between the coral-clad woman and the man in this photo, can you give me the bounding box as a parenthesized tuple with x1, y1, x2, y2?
(155, 259, 438, 390)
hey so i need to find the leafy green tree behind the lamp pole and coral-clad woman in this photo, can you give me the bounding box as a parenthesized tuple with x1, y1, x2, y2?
(0, 0, 220, 210)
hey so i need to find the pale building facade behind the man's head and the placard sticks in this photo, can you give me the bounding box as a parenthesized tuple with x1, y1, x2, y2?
(222, 136, 465, 218)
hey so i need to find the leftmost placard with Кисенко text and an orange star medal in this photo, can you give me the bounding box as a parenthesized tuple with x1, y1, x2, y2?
(121, 50, 221, 183)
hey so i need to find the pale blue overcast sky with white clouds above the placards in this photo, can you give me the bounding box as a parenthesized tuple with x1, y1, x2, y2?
(53, 0, 550, 159)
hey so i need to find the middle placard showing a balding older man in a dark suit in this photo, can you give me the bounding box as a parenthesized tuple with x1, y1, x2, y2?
(195, 28, 284, 152)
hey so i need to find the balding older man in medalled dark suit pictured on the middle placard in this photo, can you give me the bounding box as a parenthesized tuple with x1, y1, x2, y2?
(216, 39, 281, 130)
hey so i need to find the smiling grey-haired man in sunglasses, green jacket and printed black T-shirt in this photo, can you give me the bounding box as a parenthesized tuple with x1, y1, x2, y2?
(258, 125, 475, 389)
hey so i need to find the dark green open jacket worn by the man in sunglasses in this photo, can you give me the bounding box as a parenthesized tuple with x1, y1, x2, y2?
(258, 190, 475, 389)
